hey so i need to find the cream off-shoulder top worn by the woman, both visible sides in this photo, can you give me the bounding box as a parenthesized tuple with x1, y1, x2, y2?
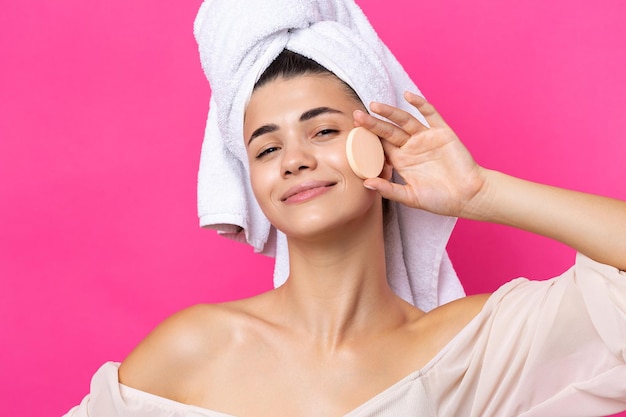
(66, 254, 626, 417)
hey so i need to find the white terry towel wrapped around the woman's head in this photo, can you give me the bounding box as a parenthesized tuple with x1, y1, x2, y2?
(194, 0, 464, 311)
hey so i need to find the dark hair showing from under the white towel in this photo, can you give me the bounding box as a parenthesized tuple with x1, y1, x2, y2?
(254, 49, 391, 226)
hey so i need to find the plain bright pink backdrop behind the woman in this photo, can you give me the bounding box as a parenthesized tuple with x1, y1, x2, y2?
(0, 0, 626, 416)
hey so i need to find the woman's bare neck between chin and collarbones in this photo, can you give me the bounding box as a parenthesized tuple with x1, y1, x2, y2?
(276, 211, 412, 351)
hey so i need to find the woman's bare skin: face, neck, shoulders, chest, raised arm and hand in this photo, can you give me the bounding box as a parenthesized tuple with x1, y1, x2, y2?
(119, 75, 626, 417)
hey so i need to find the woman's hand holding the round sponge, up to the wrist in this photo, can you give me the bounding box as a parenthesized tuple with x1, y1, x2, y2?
(354, 92, 485, 217)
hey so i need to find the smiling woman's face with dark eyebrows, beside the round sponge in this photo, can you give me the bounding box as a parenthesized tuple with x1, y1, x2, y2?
(244, 75, 380, 237)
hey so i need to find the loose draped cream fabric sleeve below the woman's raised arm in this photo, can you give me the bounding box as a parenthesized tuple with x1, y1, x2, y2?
(424, 254, 626, 417)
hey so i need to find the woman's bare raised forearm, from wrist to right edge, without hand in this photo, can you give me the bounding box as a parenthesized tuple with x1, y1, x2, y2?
(463, 170, 626, 270)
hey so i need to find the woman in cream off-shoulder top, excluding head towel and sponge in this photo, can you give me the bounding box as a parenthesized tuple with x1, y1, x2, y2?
(63, 0, 626, 416)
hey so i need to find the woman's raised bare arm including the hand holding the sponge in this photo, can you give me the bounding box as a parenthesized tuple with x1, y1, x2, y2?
(354, 93, 626, 270)
